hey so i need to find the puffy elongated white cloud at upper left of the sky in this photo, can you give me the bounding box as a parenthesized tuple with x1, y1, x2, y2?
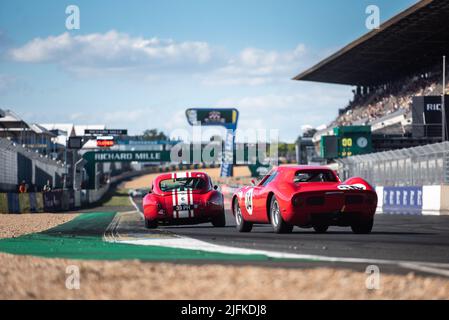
(9, 30, 212, 72)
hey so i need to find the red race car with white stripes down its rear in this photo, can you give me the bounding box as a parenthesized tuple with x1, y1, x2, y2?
(143, 172, 226, 228)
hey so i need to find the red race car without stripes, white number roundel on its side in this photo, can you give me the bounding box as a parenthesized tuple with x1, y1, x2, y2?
(231, 165, 377, 233)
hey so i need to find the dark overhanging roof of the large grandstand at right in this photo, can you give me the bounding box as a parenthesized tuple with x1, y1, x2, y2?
(293, 0, 449, 86)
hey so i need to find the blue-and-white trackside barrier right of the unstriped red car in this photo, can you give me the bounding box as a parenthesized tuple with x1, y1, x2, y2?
(376, 185, 449, 215)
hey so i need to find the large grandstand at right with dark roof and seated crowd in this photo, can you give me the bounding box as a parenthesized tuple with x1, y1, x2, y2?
(294, 0, 449, 143)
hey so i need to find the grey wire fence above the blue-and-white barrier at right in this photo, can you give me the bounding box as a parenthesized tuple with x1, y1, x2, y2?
(337, 142, 449, 186)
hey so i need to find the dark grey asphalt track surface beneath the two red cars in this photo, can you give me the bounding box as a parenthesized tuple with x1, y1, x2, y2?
(131, 198, 449, 276)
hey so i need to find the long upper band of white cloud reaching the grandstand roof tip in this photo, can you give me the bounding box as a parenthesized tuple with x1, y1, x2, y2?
(8, 30, 314, 86)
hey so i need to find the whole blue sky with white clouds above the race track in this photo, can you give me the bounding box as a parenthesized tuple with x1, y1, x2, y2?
(0, 0, 416, 141)
